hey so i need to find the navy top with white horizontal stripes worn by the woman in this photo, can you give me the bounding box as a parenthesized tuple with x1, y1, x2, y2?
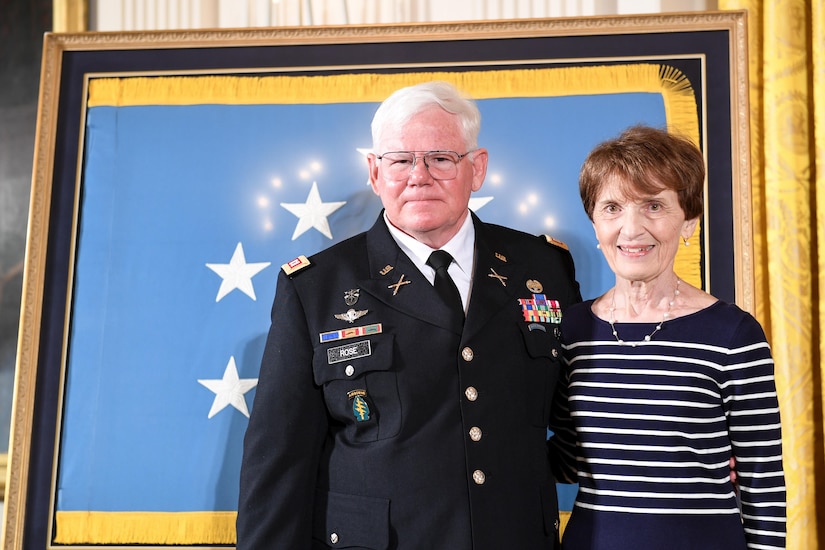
(551, 300, 785, 550)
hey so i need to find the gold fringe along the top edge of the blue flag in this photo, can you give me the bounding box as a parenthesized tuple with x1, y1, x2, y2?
(88, 63, 696, 108)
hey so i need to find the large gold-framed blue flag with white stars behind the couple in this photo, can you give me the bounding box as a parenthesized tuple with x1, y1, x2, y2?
(4, 12, 753, 548)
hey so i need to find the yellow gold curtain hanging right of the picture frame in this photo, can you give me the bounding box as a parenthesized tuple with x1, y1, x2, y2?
(719, 0, 825, 550)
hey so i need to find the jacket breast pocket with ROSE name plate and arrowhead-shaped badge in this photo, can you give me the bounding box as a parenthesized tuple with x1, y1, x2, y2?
(312, 334, 401, 442)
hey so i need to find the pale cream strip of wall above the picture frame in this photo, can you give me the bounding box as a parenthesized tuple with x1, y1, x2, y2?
(89, 0, 717, 31)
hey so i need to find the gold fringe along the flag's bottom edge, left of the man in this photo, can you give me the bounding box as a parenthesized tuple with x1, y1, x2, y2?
(54, 512, 238, 545)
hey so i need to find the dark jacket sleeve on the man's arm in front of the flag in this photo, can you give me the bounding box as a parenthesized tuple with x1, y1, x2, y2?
(237, 272, 327, 550)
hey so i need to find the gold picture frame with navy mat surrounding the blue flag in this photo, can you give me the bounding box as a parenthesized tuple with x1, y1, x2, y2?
(3, 12, 754, 549)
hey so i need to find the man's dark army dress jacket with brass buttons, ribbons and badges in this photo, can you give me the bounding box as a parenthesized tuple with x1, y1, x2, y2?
(237, 215, 581, 550)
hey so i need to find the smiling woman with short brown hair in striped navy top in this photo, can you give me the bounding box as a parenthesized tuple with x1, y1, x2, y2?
(551, 127, 785, 550)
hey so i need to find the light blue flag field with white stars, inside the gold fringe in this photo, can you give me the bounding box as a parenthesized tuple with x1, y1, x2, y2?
(57, 93, 665, 512)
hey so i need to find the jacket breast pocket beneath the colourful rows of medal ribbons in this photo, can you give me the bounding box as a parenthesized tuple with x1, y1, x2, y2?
(519, 323, 561, 426)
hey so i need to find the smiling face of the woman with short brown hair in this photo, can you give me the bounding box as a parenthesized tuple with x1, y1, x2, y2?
(593, 179, 698, 282)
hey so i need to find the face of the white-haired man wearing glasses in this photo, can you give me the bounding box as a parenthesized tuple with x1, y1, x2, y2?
(368, 106, 487, 248)
